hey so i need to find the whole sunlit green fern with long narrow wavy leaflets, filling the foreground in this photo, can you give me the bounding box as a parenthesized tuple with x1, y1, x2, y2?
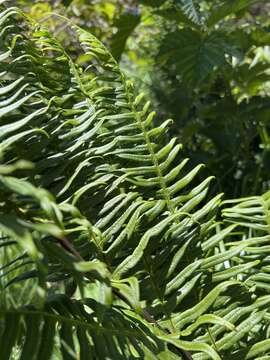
(0, 8, 270, 360)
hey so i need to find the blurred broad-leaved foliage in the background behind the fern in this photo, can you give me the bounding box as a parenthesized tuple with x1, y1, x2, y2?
(6, 0, 270, 197)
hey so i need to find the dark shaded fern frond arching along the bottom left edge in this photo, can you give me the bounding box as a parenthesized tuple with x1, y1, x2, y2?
(0, 294, 179, 360)
